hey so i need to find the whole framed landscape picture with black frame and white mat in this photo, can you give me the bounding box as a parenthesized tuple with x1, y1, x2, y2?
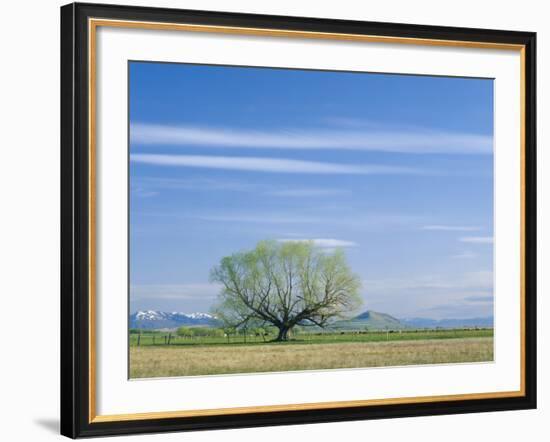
(61, 4, 536, 438)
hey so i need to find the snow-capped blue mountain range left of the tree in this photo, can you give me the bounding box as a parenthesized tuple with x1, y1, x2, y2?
(130, 310, 217, 329)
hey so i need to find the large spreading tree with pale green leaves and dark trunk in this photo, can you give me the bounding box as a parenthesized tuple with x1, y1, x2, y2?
(211, 241, 361, 341)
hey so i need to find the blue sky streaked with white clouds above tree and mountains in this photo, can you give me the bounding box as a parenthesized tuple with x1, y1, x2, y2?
(129, 62, 493, 318)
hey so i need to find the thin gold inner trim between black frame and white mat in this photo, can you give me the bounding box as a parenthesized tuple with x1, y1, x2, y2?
(88, 18, 526, 423)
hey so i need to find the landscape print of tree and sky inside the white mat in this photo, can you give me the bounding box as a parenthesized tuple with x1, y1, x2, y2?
(128, 61, 495, 378)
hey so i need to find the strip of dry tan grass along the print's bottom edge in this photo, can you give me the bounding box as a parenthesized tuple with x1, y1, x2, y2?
(130, 337, 493, 378)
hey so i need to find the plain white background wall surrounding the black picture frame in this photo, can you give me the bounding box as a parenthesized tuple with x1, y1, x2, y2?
(0, 0, 550, 442)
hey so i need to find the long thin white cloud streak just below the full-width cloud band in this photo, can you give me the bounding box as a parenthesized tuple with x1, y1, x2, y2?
(130, 153, 425, 175)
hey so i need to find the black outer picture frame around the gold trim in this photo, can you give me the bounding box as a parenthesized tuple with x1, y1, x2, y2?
(61, 3, 536, 438)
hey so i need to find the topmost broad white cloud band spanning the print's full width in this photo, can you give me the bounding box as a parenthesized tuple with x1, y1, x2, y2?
(130, 123, 492, 154)
